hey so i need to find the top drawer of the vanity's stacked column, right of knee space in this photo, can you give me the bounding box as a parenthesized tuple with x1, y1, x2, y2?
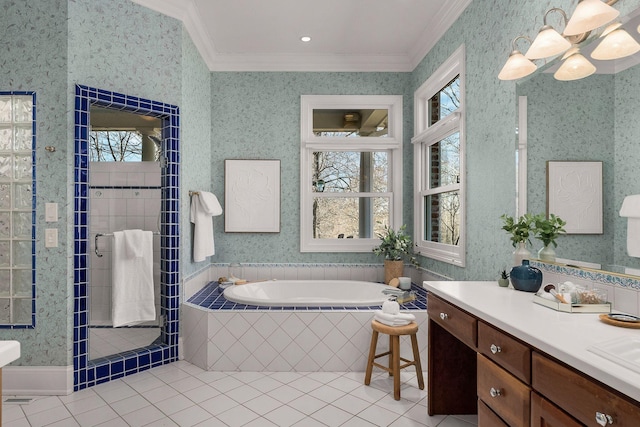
(478, 322, 531, 384)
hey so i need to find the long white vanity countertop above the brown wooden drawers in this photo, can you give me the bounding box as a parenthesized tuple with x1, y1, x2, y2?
(423, 281, 640, 402)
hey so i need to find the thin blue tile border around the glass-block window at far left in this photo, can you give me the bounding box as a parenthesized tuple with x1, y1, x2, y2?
(0, 90, 37, 329)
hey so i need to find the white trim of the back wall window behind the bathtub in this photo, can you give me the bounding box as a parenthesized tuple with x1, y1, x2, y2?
(300, 95, 402, 252)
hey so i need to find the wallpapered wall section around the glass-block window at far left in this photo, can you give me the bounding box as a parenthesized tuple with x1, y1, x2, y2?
(0, 0, 68, 365)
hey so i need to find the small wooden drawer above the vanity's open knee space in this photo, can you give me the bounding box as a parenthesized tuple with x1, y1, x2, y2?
(427, 293, 478, 349)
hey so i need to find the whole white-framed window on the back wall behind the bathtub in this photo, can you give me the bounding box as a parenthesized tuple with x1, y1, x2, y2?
(300, 95, 402, 252)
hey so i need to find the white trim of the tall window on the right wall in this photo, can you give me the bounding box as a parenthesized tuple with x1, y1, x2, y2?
(411, 45, 466, 267)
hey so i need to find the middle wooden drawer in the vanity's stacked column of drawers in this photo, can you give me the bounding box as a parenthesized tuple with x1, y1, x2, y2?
(478, 353, 531, 426)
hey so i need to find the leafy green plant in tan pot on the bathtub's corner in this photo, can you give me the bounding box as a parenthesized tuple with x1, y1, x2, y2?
(373, 224, 418, 284)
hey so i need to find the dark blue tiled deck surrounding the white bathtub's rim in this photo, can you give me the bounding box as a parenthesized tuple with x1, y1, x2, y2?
(187, 282, 427, 311)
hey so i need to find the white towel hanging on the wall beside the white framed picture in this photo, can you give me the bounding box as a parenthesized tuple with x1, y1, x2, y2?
(190, 191, 222, 262)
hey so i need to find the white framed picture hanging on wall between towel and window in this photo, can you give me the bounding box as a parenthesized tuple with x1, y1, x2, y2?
(224, 159, 280, 233)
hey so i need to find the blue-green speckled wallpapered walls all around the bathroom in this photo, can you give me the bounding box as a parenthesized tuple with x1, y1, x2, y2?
(0, 0, 640, 366)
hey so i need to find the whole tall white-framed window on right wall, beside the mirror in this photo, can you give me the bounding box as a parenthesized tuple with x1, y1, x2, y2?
(412, 47, 465, 266)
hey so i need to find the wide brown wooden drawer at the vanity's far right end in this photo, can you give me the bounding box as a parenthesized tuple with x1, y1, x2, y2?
(532, 352, 640, 427)
